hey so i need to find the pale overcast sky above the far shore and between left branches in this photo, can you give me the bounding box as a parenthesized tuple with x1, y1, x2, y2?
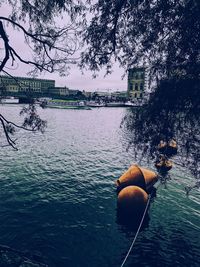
(0, 2, 127, 91)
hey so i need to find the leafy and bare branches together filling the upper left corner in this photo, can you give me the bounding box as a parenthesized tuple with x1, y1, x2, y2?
(0, 0, 84, 75)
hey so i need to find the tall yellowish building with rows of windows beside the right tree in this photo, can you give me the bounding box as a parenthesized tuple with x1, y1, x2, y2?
(127, 67, 146, 100)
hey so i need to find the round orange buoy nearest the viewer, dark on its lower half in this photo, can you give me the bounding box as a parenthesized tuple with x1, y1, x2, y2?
(117, 185, 148, 215)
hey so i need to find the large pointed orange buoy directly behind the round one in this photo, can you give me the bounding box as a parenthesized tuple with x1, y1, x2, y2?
(116, 165, 158, 191)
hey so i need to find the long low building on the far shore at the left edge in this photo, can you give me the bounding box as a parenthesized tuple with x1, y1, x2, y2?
(0, 75, 55, 94)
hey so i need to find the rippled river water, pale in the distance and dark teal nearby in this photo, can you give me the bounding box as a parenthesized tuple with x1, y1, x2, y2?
(0, 106, 200, 267)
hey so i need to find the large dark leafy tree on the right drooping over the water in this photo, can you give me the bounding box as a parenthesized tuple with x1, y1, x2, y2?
(82, 0, 200, 184)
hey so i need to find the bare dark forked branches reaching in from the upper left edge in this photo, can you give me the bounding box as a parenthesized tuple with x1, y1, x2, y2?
(0, 13, 80, 73)
